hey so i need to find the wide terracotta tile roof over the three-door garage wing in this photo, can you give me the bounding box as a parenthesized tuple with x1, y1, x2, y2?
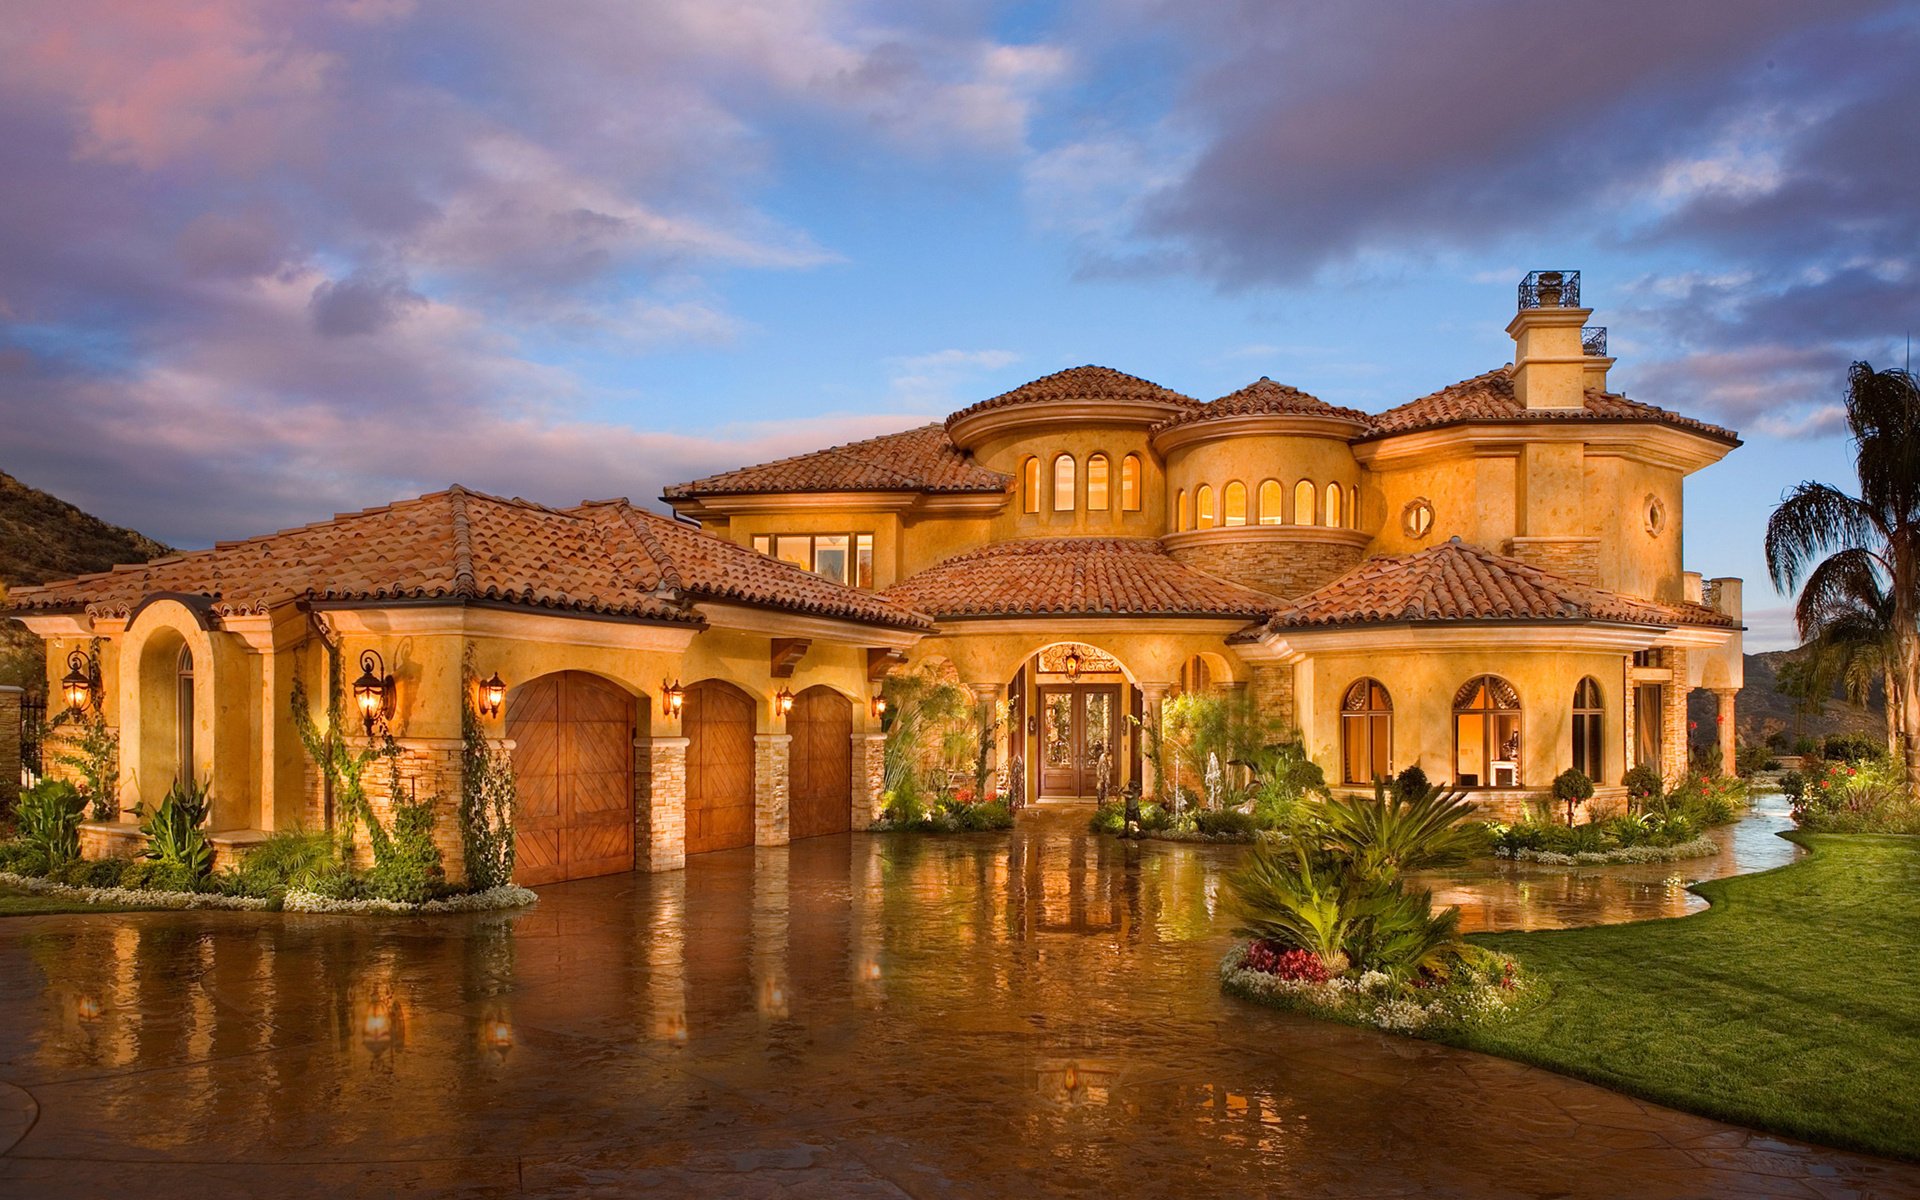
(8, 488, 927, 628)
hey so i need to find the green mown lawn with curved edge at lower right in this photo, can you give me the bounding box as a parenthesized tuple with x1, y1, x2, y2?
(1452, 833, 1920, 1158)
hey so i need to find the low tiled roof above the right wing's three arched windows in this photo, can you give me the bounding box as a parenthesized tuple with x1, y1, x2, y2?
(1267, 538, 1740, 630)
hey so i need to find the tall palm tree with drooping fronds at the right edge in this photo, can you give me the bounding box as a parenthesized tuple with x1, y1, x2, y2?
(1766, 363, 1920, 797)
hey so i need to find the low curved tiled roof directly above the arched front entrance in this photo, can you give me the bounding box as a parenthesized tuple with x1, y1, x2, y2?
(885, 538, 1283, 618)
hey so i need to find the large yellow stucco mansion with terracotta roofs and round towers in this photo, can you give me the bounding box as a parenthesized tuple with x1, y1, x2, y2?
(10, 273, 1741, 883)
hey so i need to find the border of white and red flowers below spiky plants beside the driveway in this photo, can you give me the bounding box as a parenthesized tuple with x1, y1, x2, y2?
(1219, 941, 1530, 1033)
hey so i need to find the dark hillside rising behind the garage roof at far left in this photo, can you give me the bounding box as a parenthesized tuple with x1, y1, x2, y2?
(0, 472, 173, 689)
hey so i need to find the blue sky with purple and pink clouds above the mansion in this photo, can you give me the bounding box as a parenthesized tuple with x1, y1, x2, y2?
(0, 0, 1920, 649)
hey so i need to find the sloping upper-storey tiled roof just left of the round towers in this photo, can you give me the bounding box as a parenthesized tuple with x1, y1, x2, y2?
(660, 424, 1014, 499)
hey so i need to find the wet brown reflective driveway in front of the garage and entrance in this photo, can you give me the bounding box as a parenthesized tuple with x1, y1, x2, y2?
(0, 794, 1920, 1198)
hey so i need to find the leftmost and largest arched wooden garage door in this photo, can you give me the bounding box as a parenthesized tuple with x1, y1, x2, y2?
(507, 670, 634, 885)
